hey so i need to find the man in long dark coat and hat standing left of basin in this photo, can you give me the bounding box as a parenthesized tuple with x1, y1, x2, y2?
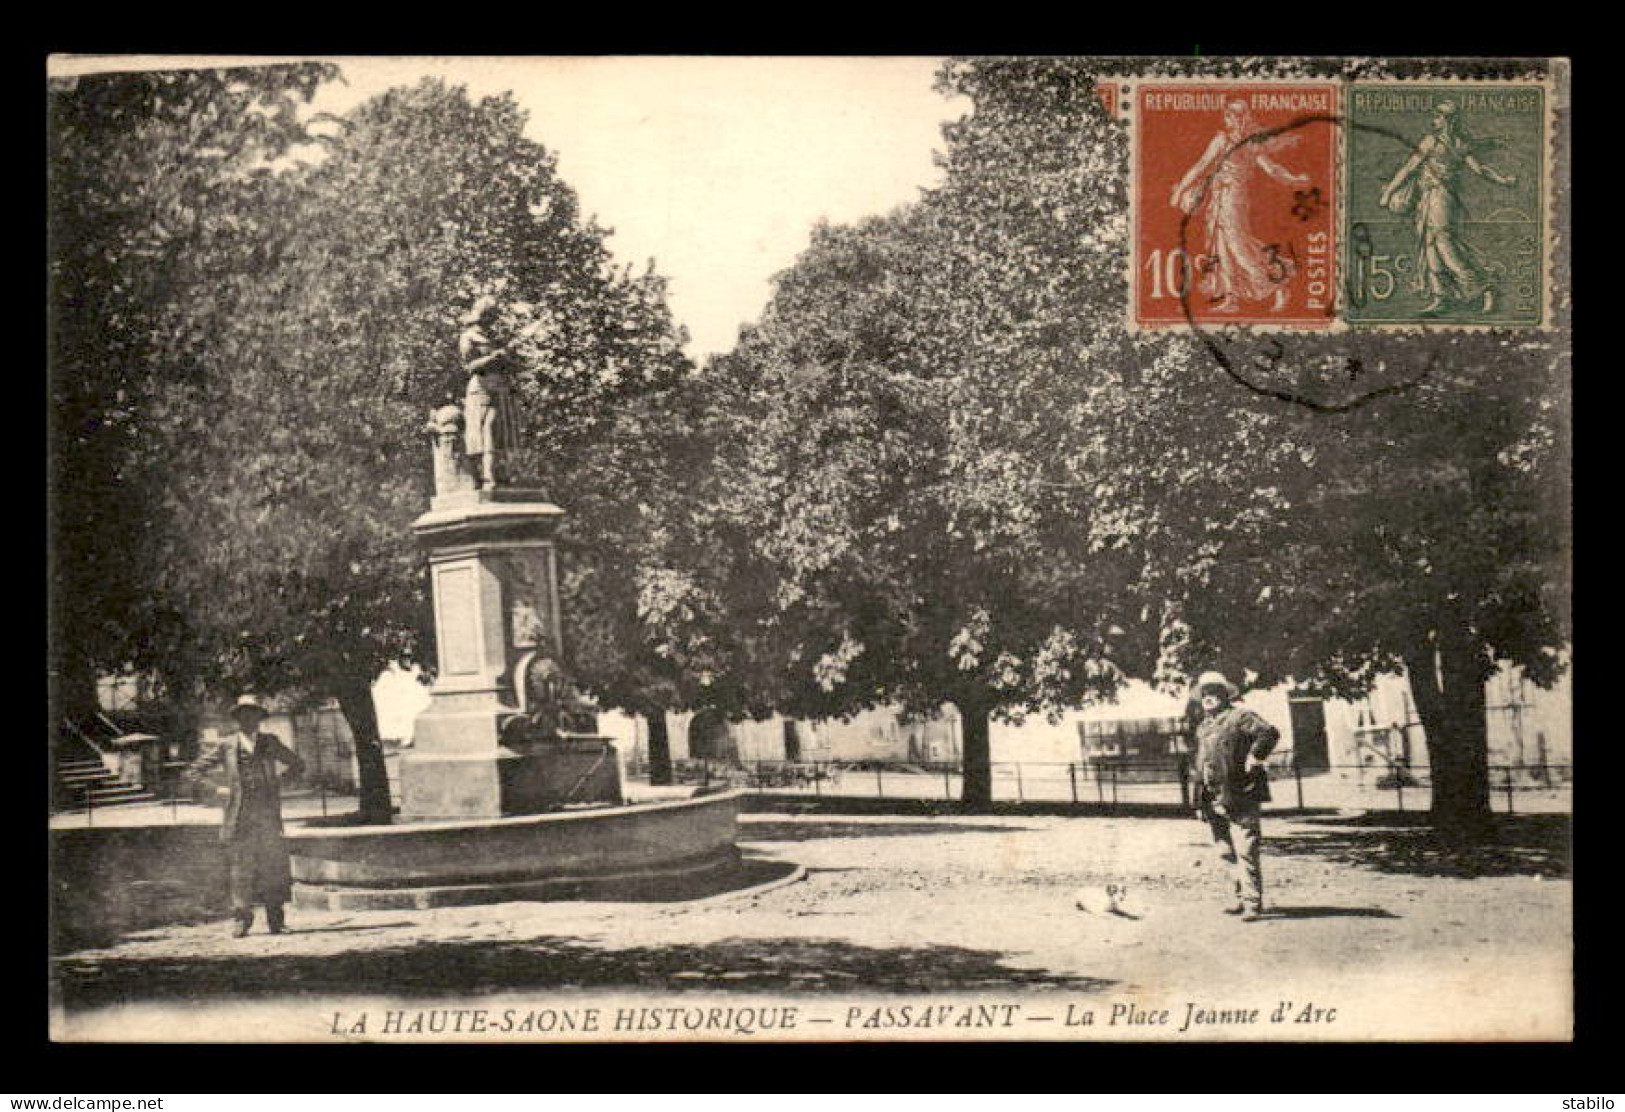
(187, 694, 304, 938)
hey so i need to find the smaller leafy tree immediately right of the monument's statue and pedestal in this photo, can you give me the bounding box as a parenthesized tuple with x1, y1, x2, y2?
(562, 347, 838, 784)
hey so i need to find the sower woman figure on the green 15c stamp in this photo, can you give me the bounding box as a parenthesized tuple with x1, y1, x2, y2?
(1378, 101, 1518, 314)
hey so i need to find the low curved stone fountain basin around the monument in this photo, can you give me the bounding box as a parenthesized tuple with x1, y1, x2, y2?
(284, 792, 741, 910)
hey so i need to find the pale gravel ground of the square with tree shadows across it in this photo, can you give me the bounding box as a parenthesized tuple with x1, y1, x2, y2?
(55, 813, 1573, 1039)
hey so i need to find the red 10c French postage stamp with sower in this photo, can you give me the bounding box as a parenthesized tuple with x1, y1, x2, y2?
(1129, 81, 1339, 328)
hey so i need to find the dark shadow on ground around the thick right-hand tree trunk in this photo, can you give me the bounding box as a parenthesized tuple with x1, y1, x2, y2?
(1268, 813, 1573, 878)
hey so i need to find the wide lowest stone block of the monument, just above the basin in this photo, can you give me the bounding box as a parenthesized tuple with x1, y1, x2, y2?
(401, 738, 622, 821)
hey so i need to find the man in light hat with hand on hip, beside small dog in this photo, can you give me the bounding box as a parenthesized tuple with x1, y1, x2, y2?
(1196, 671, 1281, 923)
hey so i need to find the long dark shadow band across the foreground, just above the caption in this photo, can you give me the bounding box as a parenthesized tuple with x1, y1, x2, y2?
(55, 938, 1116, 1008)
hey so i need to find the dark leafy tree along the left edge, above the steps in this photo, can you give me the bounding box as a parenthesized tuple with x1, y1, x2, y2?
(47, 63, 335, 717)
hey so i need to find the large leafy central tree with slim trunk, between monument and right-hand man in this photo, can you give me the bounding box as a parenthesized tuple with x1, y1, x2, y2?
(715, 200, 1126, 805)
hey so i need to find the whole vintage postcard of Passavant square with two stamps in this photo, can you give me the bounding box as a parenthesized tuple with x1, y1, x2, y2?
(44, 55, 1575, 1044)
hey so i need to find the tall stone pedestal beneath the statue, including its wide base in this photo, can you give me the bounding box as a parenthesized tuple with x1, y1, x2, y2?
(400, 488, 621, 819)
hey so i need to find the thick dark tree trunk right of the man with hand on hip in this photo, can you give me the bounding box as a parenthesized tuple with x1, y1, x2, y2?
(1406, 631, 1490, 841)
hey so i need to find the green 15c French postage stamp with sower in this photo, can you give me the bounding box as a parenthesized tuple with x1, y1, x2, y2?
(1342, 81, 1552, 328)
